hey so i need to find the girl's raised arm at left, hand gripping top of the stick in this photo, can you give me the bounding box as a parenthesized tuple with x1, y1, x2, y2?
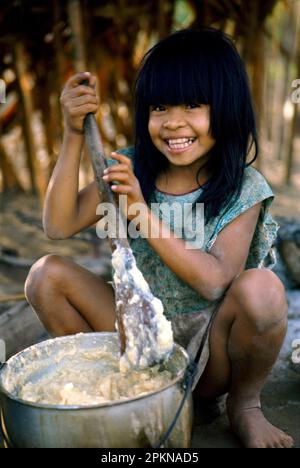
(43, 73, 100, 239)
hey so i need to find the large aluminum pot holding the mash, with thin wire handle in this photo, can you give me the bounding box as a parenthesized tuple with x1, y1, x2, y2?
(0, 333, 193, 448)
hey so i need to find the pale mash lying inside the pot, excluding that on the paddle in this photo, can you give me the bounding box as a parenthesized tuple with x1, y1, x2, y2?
(4, 335, 174, 406)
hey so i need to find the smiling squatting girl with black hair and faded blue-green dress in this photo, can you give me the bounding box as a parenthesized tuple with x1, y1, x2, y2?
(25, 29, 293, 447)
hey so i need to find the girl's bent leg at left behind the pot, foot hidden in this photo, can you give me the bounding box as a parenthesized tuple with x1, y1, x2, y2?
(25, 255, 115, 336)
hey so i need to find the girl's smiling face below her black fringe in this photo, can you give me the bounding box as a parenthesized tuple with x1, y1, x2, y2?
(148, 104, 215, 166)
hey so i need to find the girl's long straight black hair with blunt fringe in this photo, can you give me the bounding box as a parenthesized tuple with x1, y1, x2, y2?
(134, 28, 258, 222)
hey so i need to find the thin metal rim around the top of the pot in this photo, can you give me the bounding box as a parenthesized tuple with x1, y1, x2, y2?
(0, 332, 190, 411)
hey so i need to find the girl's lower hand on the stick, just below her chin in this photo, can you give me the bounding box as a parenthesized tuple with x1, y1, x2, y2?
(103, 152, 146, 220)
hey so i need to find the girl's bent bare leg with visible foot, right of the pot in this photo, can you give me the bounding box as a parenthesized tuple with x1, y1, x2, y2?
(195, 269, 293, 447)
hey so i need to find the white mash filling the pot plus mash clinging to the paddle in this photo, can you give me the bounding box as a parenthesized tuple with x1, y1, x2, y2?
(0, 246, 174, 406)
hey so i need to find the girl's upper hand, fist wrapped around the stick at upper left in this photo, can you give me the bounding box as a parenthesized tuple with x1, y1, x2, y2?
(60, 72, 99, 133)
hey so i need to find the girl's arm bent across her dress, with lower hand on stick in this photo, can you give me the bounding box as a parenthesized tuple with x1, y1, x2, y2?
(104, 153, 261, 300)
